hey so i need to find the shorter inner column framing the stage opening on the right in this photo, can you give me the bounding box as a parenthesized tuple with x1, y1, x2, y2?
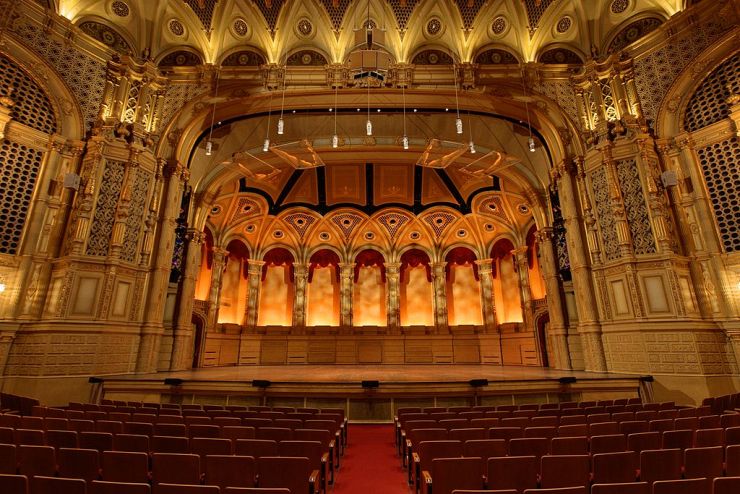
(535, 227, 572, 369)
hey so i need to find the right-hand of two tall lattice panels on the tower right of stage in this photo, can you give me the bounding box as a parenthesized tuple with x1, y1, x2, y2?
(617, 159, 655, 255)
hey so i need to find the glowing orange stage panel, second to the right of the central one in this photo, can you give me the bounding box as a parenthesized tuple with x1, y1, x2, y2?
(447, 264, 483, 326)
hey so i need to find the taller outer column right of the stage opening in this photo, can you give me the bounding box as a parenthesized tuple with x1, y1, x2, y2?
(556, 161, 607, 372)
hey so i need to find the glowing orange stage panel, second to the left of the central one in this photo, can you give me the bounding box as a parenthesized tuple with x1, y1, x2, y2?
(257, 266, 293, 326)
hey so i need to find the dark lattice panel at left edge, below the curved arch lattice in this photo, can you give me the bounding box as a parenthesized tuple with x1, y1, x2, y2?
(0, 139, 44, 255)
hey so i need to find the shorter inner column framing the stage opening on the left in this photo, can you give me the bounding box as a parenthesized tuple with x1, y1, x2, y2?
(170, 228, 205, 370)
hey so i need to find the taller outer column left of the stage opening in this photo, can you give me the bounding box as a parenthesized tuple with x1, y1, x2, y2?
(136, 160, 190, 372)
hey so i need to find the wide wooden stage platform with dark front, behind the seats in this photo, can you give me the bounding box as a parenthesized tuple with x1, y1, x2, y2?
(99, 364, 646, 422)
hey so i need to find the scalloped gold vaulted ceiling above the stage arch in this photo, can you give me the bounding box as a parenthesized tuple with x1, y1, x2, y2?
(55, 0, 686, 65)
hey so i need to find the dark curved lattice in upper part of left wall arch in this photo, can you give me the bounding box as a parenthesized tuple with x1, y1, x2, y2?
(0, 55, 57, 134)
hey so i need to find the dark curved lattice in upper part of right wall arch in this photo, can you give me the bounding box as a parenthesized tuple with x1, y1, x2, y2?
(684, 53, 740, 132)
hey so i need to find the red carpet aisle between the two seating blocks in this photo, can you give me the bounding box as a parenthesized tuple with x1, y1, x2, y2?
(332, 424, 409, 494)
